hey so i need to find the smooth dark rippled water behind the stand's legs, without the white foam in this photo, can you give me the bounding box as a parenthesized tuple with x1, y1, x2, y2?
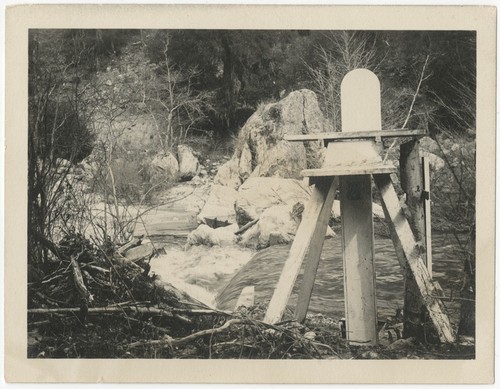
(216, 234, 463, 322)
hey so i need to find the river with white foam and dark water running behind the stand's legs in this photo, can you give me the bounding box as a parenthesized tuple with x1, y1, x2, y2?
(152, 226, 465, 324)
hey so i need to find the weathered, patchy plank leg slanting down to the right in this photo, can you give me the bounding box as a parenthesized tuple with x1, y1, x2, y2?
(374, 174, 454, 342)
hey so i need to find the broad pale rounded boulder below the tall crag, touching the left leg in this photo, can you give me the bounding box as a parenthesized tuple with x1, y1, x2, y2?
(234, 177, 311, 226)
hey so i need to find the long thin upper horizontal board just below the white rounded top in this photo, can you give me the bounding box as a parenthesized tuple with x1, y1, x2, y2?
(284, 128, 427, 142)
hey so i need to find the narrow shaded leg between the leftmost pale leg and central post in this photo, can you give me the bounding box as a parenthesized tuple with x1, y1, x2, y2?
(295, 179, 338, 322)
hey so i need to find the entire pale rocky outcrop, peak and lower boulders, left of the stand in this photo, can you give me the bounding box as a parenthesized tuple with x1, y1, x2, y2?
(191, 89, 329, 247)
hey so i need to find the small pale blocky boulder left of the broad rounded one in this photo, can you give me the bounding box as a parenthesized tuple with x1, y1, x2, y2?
(198, 185, 238, 228)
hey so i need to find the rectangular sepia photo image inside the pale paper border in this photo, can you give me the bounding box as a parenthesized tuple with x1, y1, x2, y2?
(3, 3, 493, 384)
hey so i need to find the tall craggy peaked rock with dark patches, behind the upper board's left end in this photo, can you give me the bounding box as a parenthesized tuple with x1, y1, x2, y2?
(215, 89, 329, 188)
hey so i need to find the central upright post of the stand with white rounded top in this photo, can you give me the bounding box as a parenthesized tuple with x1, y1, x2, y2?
(340, 69, 382, 345)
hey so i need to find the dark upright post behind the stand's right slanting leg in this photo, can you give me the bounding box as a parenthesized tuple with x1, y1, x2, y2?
(399, 140, 425, 338)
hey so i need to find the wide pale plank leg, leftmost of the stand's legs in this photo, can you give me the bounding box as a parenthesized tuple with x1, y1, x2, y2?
(264, 178, 335, 324)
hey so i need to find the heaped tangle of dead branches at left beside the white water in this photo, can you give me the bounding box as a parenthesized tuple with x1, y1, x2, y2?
(28, 234, 175, 312)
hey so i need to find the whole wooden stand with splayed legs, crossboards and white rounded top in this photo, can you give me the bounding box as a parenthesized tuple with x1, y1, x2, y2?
(264, 69, 453, 345)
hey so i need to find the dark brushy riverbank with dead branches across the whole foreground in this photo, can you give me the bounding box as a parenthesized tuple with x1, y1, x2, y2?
(28, 234, 473, 359)
